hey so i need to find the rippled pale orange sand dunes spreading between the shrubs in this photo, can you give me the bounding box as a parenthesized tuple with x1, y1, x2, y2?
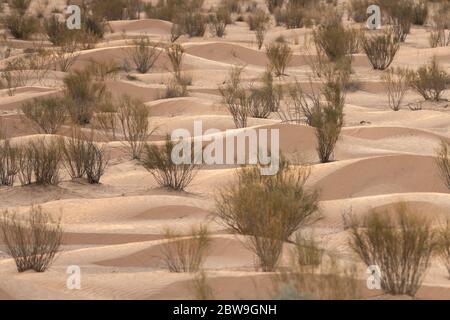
(0, 1, 450, 299)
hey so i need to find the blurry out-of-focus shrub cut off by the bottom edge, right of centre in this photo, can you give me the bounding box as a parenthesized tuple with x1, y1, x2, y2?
(273, 253, 362, 300)
